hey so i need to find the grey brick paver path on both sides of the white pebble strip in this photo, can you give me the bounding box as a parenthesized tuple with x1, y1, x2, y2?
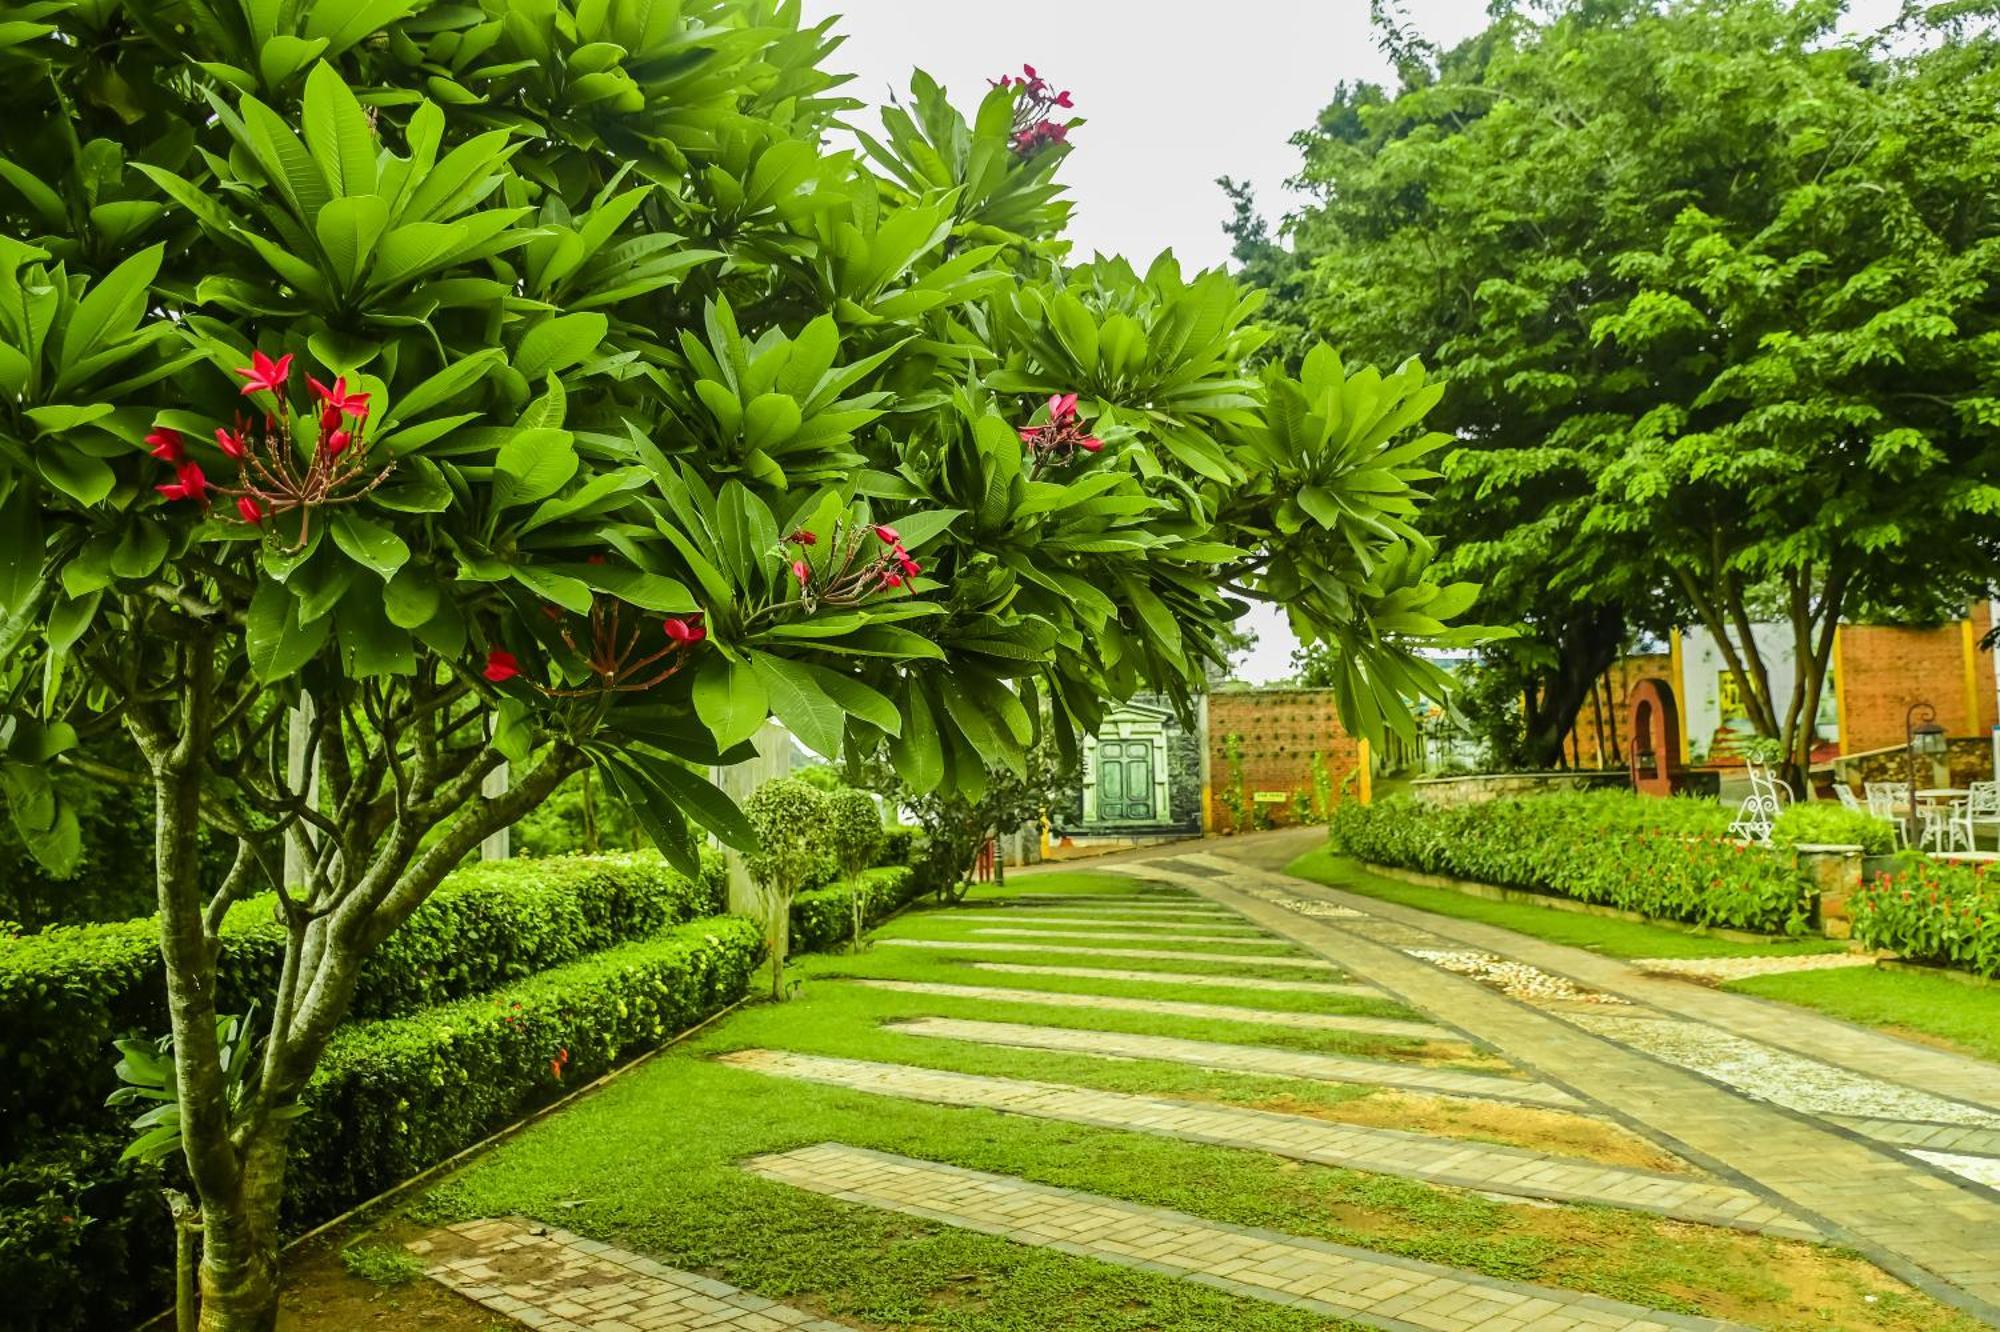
(1148, 858, 2000, 1326)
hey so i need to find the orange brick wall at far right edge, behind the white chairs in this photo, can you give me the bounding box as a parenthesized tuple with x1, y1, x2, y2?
(1834, 602, 1994, 754)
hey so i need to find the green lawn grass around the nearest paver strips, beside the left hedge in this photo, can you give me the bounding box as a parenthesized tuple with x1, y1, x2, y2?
(398, 984, 1972, 1332)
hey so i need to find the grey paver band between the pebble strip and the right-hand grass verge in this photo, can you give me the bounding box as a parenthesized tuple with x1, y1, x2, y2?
(1188, 854, 2000, 1112)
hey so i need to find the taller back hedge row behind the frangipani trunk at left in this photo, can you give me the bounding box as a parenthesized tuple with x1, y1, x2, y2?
(0, 852, 726, 1154)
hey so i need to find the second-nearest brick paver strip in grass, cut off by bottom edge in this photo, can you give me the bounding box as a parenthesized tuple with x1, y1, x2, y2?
(746, 1142, 1736, 1332)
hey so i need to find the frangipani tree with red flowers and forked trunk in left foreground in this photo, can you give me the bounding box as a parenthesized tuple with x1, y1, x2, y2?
(0, 0, 1472, 1332)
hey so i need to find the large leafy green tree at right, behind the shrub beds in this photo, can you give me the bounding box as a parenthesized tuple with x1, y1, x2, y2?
(1234, 0, 2000, 764)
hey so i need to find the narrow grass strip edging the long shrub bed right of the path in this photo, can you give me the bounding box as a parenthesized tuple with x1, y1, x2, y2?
(1284, 850, 1846, 958)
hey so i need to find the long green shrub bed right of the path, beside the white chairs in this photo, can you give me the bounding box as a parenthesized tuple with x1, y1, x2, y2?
(1332, 792, 1808, 934)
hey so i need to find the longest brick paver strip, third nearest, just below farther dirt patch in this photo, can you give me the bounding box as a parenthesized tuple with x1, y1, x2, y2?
(716, 1050, 1816, 1240)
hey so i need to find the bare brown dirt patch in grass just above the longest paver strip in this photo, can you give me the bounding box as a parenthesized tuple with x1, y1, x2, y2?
(1254, 1092, 1694, 1174)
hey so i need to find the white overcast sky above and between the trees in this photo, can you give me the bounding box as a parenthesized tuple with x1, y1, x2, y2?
(806, 0, 1898, 682)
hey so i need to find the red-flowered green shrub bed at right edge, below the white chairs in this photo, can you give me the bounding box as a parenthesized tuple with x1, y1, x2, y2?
(1848, 856, 2000, 976)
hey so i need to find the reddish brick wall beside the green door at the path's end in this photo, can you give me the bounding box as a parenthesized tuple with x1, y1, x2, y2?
(1208, 690, 1360, 832)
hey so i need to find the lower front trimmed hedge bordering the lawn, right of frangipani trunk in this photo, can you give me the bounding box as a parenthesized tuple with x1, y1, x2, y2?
(286, 916, 764, 1222)
